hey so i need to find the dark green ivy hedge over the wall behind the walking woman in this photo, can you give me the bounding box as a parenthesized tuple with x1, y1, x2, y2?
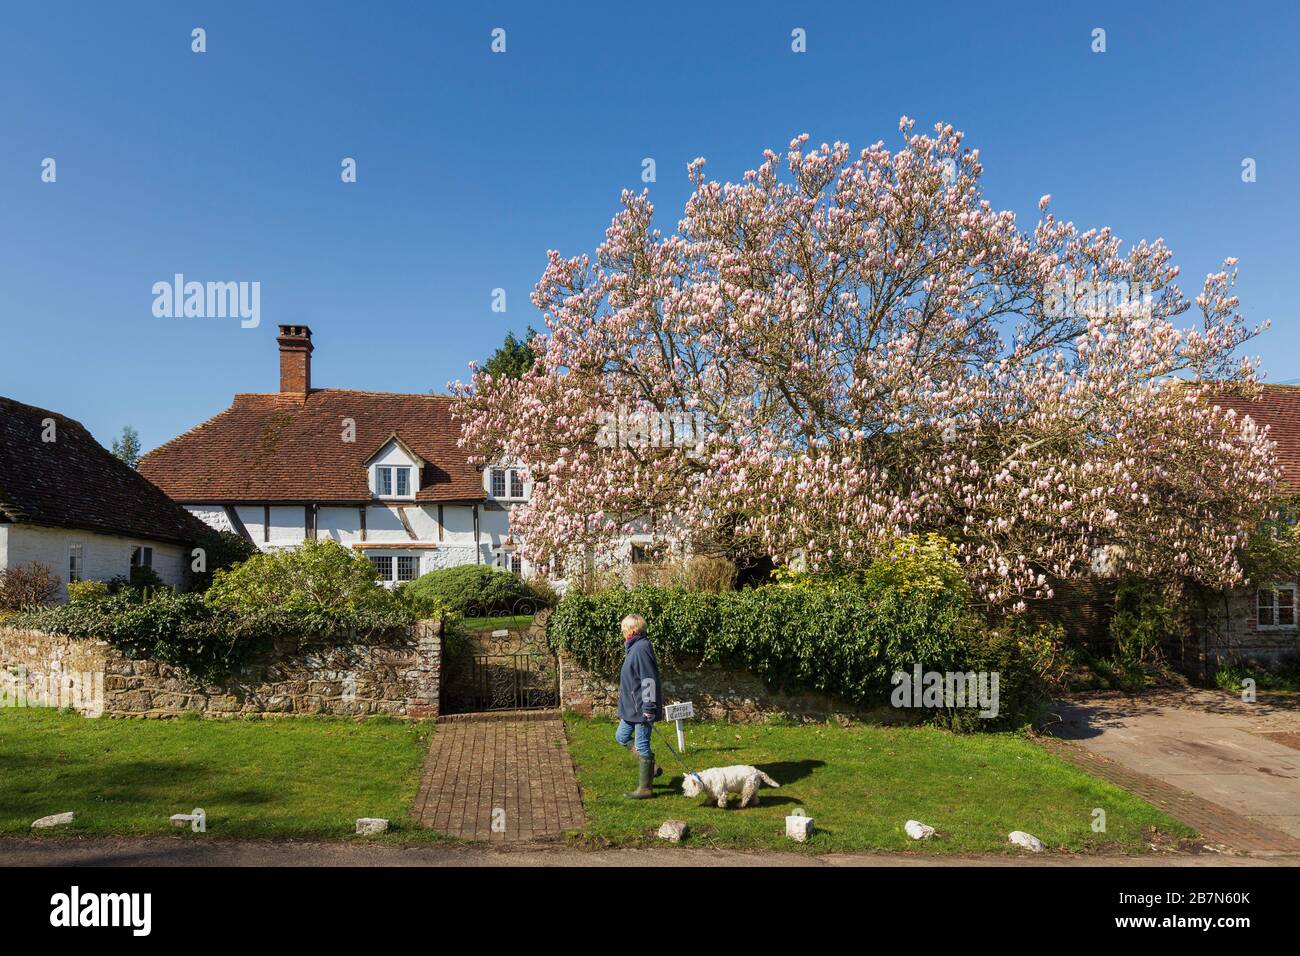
(547, 583, 1045, 730)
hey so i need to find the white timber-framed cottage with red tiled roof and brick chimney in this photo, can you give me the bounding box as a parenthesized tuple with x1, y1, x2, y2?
(139, 325, 532, 584)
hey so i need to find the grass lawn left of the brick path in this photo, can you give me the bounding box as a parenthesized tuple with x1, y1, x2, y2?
(0, 708, 432, 839)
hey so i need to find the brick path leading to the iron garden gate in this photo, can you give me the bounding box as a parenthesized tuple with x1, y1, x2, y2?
(415, 714, 585, 843)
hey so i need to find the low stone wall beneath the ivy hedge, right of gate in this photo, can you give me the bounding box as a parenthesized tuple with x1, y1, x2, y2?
(558, 650, 899, 723)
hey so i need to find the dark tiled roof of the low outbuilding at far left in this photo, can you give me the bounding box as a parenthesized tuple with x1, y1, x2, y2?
(0, 398, 207, 544)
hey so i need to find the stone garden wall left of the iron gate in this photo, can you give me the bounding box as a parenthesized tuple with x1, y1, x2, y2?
(0, 620, 442, 718)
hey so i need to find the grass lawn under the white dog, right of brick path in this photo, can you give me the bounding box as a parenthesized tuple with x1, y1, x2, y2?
(566, 715, 1193, 853)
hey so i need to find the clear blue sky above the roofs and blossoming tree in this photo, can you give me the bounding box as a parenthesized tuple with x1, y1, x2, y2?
(0, 1, 1300, 449)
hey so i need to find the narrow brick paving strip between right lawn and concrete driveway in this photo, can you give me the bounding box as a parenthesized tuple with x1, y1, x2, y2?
(1039, 737, 1300, 853)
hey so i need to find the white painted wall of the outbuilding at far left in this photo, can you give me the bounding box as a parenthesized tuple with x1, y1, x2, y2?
(0, 524, 187, 601)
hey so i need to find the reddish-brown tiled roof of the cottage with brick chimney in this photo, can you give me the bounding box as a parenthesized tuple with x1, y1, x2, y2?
(140, 389, 485, 503)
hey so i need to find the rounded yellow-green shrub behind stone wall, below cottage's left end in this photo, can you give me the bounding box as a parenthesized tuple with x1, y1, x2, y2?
(205, 540, 404, 615)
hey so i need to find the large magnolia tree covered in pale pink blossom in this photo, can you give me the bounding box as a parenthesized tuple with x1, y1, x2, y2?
(454, 118, 1278, 604)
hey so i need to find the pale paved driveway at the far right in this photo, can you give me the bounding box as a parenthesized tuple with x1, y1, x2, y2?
(1052, 692, 1300, 839)
